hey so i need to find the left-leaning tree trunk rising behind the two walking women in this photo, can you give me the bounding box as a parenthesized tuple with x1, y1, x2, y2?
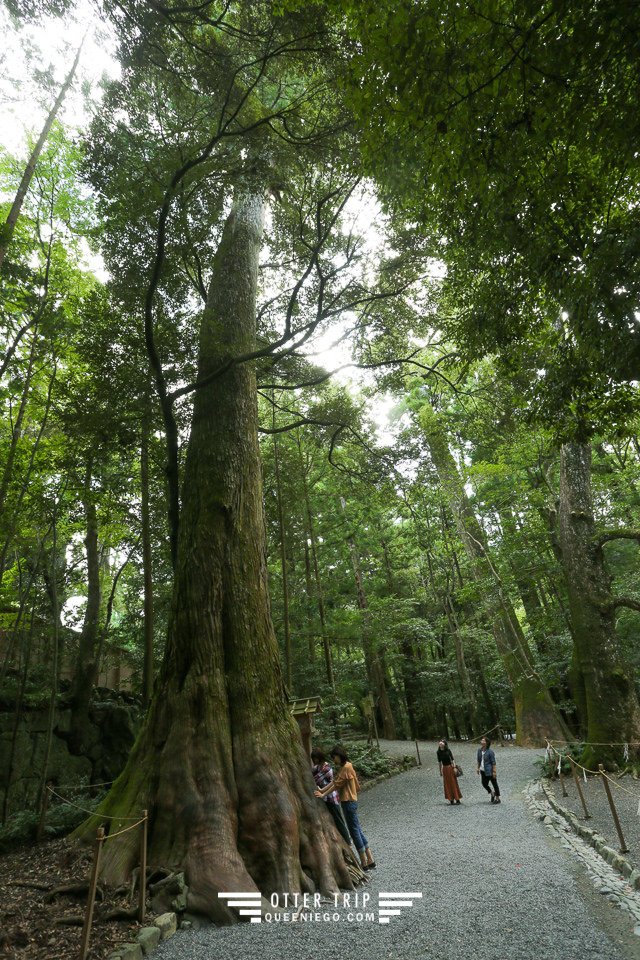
(420, 405, 569, 746)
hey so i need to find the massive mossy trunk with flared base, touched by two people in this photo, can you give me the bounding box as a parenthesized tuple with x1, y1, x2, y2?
(79, 182, 351, 921)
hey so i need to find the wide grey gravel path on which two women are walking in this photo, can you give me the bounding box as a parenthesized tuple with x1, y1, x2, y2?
(154, 742, 640, 960)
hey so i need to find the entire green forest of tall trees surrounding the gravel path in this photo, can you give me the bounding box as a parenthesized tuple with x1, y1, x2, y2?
(0, 0, 640, 920)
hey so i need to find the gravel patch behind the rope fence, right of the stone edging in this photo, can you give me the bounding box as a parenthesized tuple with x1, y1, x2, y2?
(547, 764, 640, 869)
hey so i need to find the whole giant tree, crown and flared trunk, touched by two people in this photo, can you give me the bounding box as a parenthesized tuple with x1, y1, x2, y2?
(76, 4, 390, 920)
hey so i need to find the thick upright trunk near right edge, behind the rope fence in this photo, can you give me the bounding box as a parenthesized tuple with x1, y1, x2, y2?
(559, 443, 640, 763)
